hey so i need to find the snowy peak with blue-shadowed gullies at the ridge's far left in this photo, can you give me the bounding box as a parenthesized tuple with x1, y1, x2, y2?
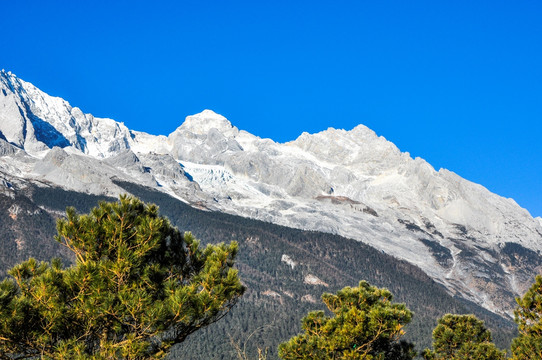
(0, 71, 138, 158)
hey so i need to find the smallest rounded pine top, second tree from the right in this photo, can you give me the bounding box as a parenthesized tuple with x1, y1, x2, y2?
(423, 314, 506, 360)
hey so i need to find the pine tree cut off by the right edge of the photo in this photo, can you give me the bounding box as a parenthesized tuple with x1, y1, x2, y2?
(512, 275, 542, 360)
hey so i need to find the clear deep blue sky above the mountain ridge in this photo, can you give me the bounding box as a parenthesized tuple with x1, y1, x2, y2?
(0, 0, 542, 216)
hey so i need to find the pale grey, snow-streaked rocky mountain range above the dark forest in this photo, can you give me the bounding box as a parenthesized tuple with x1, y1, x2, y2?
(0, 71, 542, 314)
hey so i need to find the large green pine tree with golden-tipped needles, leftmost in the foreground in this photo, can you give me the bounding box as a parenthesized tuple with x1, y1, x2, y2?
(0, 196, 244, 360)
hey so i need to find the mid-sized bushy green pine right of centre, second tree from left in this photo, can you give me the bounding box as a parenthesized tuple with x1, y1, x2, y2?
(279, 281, 415, 360)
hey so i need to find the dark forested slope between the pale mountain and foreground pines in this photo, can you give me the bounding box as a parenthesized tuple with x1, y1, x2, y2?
(0, 182, 515, 359)
